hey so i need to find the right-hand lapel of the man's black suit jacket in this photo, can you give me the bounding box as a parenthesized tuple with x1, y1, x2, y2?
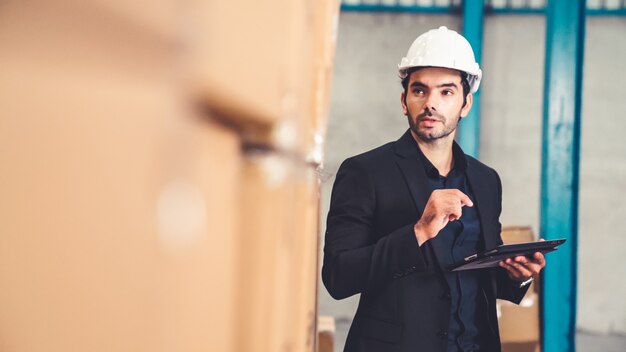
(467, 162, 497, 249)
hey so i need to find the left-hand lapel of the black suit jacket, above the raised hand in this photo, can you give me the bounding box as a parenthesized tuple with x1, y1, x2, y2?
(394, 130, 430, 216)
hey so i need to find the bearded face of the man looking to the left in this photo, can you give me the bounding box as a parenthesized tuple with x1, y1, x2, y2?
(401, 67, 472, 142)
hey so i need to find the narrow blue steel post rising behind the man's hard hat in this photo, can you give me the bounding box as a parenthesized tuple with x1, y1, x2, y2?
(459, 0, 484, 158)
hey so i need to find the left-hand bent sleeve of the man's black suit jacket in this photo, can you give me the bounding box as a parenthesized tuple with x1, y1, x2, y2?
(322, 158, 426, 299)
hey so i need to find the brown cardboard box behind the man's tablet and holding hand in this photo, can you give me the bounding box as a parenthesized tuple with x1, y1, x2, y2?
(497, 227, 540, 352)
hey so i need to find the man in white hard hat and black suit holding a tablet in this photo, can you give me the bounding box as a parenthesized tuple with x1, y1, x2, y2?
(322, 27, 545, 352)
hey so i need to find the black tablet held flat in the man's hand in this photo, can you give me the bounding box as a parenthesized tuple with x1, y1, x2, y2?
(449, 238, 566, 271)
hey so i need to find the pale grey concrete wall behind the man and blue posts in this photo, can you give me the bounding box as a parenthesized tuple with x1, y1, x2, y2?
(320, 12, 626, 346)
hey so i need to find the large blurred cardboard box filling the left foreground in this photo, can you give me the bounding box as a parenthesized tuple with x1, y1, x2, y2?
(0, 0, 241, 352)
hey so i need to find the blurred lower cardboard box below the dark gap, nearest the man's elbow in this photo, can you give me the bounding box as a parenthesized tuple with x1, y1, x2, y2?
(237, 155, 317, 352)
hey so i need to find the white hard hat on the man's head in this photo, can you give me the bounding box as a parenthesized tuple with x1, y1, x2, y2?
(398, 26, 483, 93)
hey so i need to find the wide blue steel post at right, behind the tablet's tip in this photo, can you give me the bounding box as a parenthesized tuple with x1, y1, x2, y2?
(540, 0, 585, 352)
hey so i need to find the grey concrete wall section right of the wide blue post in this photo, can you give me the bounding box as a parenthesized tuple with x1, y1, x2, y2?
(577, 17, 626, 334)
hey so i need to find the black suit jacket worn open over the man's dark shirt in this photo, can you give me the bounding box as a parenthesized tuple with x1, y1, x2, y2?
(322, 131, 527, 352)
